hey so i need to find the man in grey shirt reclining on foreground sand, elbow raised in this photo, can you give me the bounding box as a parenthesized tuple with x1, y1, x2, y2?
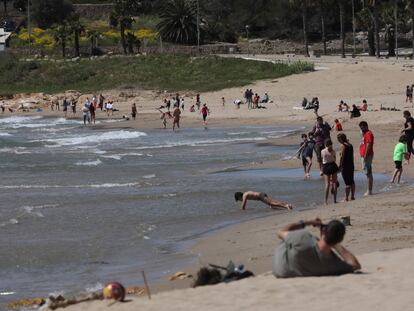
(273, 218, 361, 278)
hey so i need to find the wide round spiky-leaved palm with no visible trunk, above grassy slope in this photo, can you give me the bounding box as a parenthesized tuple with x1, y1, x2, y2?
(157, 0, 198, 44)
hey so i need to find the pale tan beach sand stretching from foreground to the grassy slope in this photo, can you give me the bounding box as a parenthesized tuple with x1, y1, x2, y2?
(6, 58, 414, 310)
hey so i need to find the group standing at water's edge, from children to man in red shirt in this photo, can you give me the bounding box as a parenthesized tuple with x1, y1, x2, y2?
(298, 117, 374, 205)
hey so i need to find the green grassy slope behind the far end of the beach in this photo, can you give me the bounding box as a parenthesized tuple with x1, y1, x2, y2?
(0, 54, 313, 94)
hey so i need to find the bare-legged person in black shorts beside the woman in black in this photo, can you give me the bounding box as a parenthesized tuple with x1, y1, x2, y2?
(321, 139, 339, 205)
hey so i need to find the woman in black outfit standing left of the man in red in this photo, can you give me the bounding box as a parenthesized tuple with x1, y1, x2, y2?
(337, 133, 355, 201)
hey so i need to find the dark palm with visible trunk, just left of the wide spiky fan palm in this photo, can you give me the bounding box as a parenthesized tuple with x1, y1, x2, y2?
(111, 0, 142, 55)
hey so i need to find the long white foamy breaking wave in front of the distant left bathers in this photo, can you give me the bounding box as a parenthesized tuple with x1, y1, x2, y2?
(40, 130, 147, 146)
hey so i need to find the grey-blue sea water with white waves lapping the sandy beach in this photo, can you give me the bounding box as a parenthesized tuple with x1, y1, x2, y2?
(0, 116, 388, 304)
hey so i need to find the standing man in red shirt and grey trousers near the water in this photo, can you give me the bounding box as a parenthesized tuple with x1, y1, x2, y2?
(359, 121, 374, 196)
